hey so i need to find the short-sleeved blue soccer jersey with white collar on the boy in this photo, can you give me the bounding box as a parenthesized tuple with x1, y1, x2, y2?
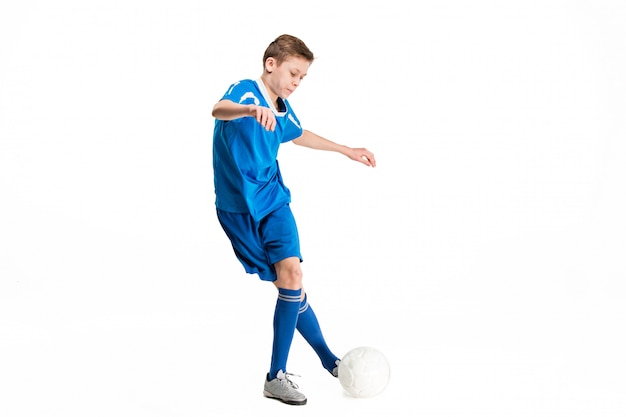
(213, 80, 302, 220)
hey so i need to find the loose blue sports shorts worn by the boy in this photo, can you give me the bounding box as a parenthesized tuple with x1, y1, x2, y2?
(217, 204, 302, 281)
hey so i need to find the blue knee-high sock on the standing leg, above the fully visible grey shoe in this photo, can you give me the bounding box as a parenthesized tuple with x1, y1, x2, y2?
(269, 288, 302, 379)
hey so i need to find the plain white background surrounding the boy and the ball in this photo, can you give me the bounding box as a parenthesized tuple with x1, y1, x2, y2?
(0, 0, 626, 417)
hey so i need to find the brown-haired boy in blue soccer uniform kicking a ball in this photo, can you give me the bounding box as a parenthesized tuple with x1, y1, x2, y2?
(212, 35, 376, 405)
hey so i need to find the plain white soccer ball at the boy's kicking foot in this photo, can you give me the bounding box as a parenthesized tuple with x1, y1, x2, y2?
(337, 346, 390, 398)
